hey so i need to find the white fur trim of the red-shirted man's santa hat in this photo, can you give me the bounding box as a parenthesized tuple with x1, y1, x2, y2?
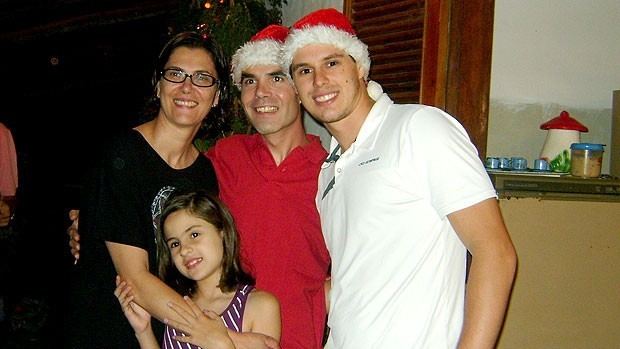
(231, 40, 282, 87)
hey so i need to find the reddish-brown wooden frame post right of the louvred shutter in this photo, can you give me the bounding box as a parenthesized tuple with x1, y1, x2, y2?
(343, 0, 495, 158)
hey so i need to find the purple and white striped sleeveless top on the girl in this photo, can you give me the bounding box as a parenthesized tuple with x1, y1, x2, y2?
(161, 285, 254, 349)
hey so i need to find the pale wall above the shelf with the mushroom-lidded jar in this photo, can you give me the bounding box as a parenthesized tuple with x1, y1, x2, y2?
(487, 0, 620, 173)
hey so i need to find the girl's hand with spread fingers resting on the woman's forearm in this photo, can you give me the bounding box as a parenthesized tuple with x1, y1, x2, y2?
(164, 296, 234, 349)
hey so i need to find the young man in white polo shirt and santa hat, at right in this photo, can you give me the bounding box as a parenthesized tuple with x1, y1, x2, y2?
(283, 9, 516, 349)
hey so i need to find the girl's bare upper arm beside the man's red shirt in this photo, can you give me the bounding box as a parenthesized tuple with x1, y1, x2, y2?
(243, 289, 282, 342)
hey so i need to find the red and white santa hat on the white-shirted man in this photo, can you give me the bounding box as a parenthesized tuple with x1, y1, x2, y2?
(282, 8, 370, 79)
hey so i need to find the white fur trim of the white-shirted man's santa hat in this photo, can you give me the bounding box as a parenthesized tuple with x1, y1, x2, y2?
(282, 25, 370, 79)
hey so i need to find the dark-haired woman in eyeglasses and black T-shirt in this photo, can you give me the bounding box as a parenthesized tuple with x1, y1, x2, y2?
(62, 32, 276, 348)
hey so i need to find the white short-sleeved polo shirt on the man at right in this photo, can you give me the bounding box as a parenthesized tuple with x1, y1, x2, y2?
(317, 90, 496, 349)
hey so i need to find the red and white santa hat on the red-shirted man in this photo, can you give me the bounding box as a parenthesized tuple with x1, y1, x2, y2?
(231, 24, 288, 86)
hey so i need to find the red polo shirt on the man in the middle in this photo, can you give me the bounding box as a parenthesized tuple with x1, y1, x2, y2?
(207, 134, 330, 349)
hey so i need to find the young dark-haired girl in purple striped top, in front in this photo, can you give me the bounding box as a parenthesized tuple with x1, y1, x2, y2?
(114, 192, 281, 349)
